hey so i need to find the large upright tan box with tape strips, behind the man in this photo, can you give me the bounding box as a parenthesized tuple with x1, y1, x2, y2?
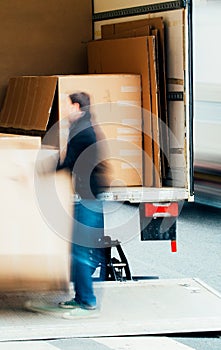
(58, 74, 143, 186)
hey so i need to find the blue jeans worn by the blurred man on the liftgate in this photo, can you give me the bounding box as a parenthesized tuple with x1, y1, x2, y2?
(71, 200, 106, 305)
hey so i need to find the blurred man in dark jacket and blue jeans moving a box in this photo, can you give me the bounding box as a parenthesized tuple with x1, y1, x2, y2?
(57, 92, 109, 318)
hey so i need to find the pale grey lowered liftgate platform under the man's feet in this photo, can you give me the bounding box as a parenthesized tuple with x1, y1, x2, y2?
(0, 279, 221, 342)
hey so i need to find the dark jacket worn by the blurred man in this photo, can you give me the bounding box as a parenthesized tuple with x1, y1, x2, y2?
(57, 112, 106, 199)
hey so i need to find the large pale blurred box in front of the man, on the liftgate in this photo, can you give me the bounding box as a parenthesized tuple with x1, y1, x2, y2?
(0, 149, 73, 291)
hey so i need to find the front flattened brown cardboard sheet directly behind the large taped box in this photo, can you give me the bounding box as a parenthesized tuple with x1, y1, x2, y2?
(88, 37, 153, 186)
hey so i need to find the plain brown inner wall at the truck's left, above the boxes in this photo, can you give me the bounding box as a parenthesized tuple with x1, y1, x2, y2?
(0, 0, 92, 109)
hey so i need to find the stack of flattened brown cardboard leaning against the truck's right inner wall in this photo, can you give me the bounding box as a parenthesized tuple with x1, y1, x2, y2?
(88, 17, 168, 187)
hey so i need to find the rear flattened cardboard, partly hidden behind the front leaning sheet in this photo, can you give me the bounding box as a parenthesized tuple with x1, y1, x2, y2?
(101, 17, 168, 187)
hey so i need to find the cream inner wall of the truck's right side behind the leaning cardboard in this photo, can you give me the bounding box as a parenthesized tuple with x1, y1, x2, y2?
(94, 0, 188, 188)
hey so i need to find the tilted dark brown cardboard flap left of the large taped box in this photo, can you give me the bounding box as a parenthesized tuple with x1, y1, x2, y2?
(0, 76, 58, 131)
